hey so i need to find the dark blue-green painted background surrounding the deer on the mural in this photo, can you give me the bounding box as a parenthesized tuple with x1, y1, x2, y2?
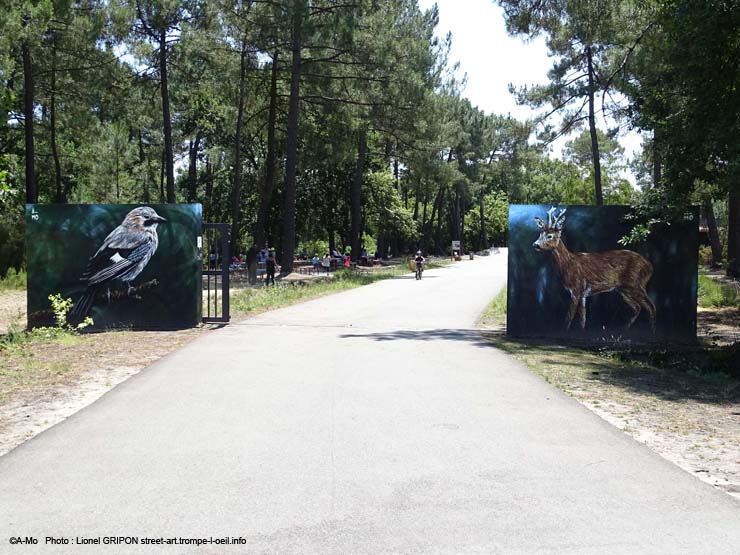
(507, 205, 699, 342)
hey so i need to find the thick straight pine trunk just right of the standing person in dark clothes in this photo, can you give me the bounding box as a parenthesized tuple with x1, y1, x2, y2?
(281, 14, 301, 275)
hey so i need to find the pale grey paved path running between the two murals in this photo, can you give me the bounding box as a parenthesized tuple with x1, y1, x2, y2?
(0, 253, 740, 555)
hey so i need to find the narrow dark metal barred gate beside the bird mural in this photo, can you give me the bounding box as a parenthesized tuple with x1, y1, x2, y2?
(201, 223, 231, 323)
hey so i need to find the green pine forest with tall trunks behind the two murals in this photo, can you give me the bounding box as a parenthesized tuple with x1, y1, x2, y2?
(0, 0, 740, 274)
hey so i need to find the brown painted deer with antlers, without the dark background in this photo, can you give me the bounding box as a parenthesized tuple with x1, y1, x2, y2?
(532, 207, 655, 332)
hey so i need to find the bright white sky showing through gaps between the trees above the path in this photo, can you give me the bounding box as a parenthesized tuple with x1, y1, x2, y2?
(418, 0, 640, 180)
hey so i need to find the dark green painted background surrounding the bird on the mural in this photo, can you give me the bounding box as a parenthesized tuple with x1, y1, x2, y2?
(26, 204, 202, 329)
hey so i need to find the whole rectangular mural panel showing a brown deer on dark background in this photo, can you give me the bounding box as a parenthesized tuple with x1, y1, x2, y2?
(507, 205, 698, 342)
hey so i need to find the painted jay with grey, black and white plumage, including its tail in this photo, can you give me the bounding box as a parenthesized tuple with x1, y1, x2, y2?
(71, 206, 167, 321)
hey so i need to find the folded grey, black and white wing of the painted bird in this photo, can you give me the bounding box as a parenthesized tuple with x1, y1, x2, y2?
(81, 227, 154, 286)
